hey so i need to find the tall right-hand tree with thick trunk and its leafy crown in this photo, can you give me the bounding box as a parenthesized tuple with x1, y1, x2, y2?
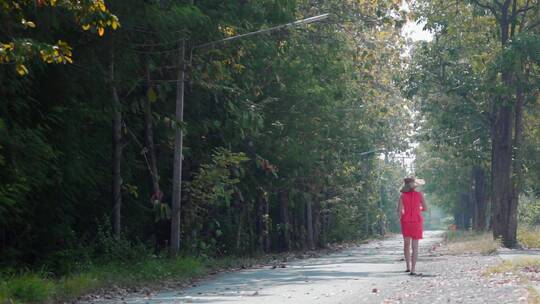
(410, 1, 538, 247)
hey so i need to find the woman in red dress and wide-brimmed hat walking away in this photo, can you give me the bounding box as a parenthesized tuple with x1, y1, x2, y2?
(398, 177, 427, 275)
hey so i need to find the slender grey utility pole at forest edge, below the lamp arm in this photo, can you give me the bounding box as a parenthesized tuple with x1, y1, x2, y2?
(171, 41, 186, 255)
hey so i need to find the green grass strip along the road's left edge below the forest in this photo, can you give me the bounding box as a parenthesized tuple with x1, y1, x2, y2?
(0, 257, 250, 304)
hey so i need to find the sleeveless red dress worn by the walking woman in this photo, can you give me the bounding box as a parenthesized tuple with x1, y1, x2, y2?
(400, 190, 424, 240)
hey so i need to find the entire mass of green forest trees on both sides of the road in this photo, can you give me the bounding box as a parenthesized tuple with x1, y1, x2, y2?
(0, 0, 540, 300)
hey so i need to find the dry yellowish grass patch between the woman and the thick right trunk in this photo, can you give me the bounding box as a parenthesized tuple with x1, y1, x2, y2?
(445, 230, 501, 254)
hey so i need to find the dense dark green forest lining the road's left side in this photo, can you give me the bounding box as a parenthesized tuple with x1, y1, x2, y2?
(0, 0, 410, 271)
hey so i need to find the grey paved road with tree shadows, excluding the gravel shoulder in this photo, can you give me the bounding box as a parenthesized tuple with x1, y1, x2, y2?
(96, 231, 442, 304)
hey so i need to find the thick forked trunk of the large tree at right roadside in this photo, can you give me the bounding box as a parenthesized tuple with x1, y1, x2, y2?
(472, 0, 539, 247)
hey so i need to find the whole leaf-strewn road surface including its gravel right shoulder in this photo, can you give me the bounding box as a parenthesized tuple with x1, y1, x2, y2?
(83, 231, 526, 304)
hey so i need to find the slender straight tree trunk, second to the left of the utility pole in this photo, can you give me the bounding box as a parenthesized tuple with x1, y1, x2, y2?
(110, 47, 123, 238)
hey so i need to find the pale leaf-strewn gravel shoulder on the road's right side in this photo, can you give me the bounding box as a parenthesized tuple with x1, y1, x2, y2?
(382, 254, 527, 304)
